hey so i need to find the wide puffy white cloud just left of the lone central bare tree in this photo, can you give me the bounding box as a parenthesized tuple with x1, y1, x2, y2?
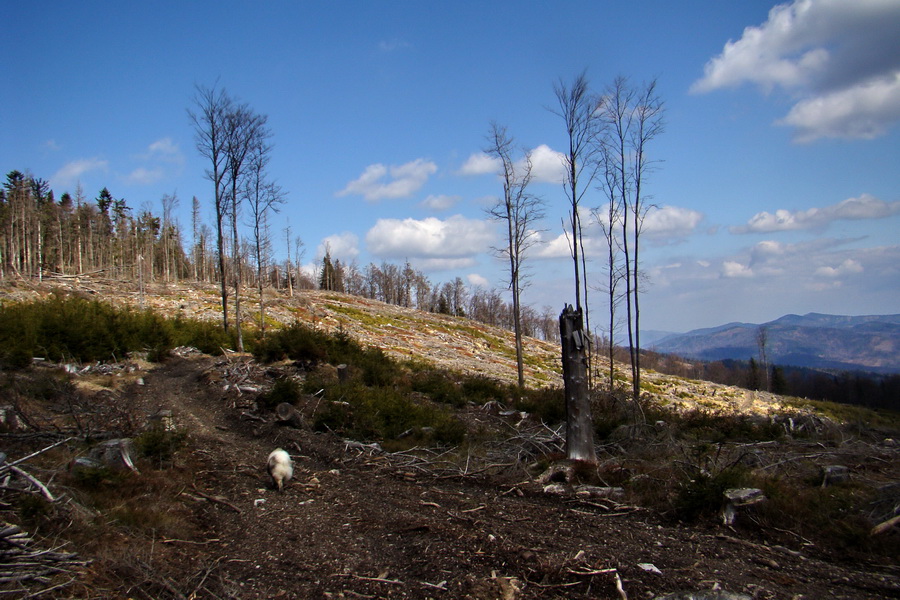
(366, 215, 495, 260)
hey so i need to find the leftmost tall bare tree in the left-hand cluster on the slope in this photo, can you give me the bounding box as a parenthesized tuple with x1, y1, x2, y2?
(188, 84, 234, 331)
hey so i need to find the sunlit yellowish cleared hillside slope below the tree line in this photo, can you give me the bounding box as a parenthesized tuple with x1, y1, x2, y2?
(0, 279, 796, 415)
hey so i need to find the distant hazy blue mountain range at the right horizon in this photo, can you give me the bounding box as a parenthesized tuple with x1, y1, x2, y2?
(642, 313, 900, 373)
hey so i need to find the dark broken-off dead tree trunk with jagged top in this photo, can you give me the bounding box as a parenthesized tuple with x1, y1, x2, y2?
(559, 305, 597, 463)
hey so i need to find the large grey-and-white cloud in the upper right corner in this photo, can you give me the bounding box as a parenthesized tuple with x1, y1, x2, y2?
(691, 0, 900, 142)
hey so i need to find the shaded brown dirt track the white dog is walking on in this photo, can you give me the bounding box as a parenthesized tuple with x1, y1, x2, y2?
(107, 357, 900, 600)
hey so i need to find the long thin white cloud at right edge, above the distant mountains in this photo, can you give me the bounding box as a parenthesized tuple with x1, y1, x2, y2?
(730, 194, 900, 233)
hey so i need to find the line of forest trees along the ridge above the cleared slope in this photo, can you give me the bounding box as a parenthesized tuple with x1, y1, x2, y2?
(0, 170, 559, 340)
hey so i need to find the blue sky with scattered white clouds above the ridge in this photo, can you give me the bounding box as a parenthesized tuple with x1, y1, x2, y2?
(0, 0, 900, 331)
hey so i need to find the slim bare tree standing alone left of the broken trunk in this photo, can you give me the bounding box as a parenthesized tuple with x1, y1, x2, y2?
(485, 123, 544, 388)
